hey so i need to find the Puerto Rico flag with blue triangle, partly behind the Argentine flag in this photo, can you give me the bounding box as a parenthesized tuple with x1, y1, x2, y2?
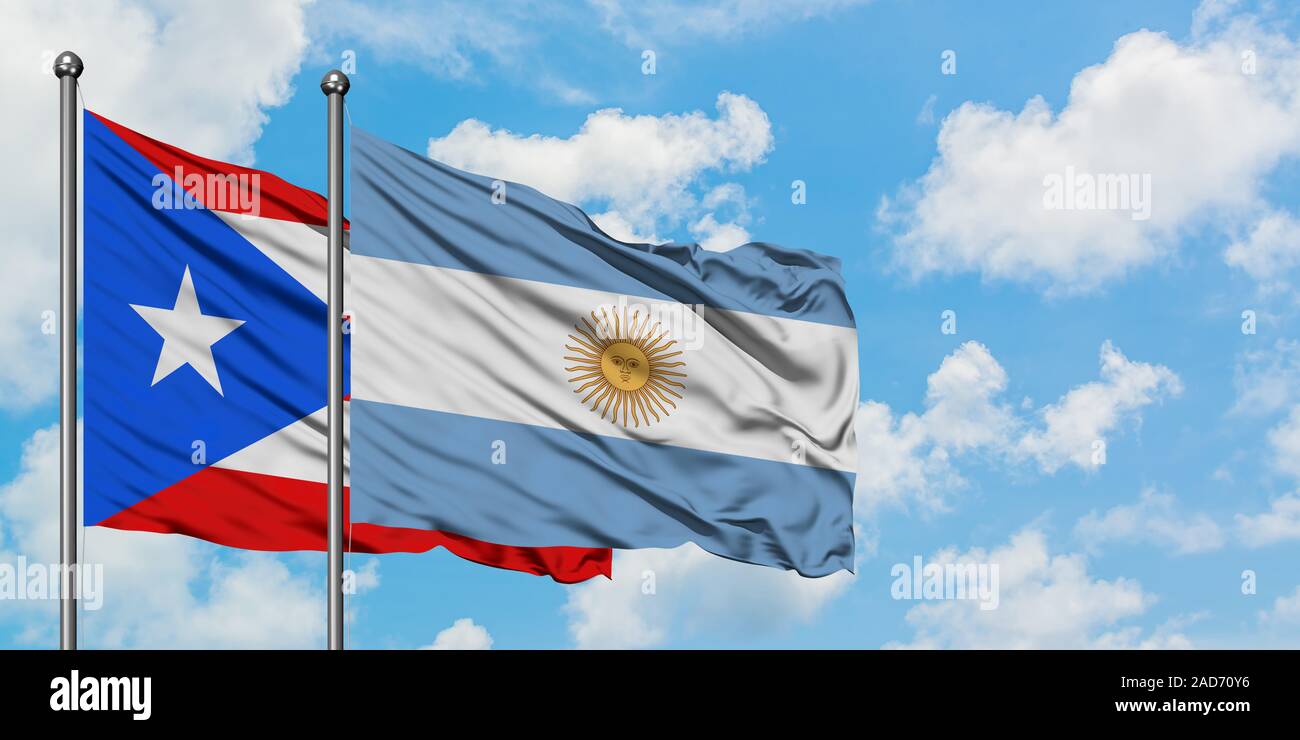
(83, 111, 611, 583)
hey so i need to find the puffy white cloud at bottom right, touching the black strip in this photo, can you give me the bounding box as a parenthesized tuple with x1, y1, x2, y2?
(888, 528, 1188, 649)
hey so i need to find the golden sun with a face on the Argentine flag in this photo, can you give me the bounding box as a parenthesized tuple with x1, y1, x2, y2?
(564, 308, 686, 427)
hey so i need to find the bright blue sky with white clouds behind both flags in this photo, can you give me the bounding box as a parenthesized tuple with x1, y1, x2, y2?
(0, 0, 1300, 648)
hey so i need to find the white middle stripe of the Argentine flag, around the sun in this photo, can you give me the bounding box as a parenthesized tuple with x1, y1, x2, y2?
(351, 255, 858, 472)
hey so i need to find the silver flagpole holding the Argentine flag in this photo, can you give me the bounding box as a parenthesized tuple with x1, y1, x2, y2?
(321, 69, 351, 650)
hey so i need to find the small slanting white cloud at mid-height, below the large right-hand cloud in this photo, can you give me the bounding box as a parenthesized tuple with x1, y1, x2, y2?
(1018, 339, 1183, 473)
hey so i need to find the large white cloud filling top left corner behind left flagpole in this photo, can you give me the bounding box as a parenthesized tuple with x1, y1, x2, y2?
(0, 0, 307, 408)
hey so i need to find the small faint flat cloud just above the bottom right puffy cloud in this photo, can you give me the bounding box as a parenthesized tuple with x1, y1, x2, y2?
(1074, 488, 1226, 555)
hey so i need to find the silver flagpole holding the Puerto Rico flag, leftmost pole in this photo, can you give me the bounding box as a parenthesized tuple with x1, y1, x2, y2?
(55, 52, 83, 650)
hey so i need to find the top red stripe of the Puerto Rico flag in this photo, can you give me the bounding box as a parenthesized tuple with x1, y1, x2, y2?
(88, 111, 348, 229)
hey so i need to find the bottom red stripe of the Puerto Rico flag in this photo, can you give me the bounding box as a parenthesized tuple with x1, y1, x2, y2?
(99, 467, 612, 583)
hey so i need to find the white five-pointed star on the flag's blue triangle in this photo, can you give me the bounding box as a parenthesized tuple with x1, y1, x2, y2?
(131, 265, 243, 395)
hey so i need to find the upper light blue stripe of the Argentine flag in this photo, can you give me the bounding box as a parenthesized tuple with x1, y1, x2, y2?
(351, 129, 854, 326)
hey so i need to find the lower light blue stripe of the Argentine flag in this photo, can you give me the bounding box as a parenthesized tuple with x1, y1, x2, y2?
(351, 399, 854, 576)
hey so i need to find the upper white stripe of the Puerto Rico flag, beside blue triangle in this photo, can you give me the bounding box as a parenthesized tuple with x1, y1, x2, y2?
(213, 211, 350, 302)
